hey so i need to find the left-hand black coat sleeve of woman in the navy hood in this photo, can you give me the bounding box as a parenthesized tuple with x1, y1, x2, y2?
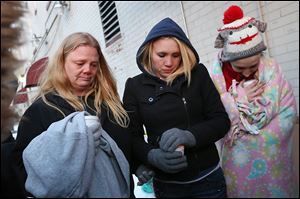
(123, 78, 153, 166)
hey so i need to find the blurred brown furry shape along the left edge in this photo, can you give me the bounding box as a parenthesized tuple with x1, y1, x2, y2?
(1, 1, 26, 141)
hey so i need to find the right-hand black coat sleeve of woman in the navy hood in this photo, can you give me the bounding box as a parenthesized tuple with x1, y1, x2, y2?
(188, 65, 230, 147)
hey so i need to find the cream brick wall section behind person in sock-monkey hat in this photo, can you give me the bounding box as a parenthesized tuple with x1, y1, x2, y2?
(183, 1, 299, 115)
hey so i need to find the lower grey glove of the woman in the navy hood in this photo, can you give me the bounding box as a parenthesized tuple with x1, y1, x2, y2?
(148, 149, 188, 173)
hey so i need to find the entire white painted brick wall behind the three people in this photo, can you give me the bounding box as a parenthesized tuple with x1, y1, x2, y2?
(25, 1, 299, 112)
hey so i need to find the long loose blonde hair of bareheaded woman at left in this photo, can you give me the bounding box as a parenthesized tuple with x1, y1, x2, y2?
(37, 32, 129, 127)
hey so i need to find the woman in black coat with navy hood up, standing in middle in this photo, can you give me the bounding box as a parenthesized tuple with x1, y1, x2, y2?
(123, 18, 230, 197)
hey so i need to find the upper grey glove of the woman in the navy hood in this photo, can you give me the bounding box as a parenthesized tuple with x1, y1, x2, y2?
(159, 128, 196, 152)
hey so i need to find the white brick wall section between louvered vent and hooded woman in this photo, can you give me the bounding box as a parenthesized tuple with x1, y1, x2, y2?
(104, 1, 183, 97)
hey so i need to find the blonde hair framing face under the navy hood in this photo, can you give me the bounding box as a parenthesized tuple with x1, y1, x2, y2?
(139, 37, 197, 85)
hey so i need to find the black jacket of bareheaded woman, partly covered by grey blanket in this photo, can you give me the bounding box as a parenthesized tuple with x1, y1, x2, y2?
(13, 94, 134, 196)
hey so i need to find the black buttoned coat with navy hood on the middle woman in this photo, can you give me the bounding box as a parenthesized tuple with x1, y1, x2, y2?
(123, 19, 230, 181)
